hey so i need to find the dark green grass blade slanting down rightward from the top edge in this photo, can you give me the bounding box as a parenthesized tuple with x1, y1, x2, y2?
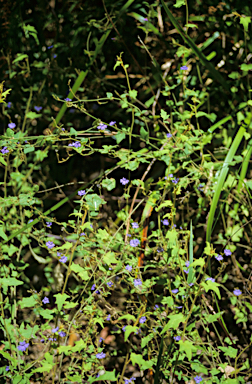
(161, 0, 230, 91)
